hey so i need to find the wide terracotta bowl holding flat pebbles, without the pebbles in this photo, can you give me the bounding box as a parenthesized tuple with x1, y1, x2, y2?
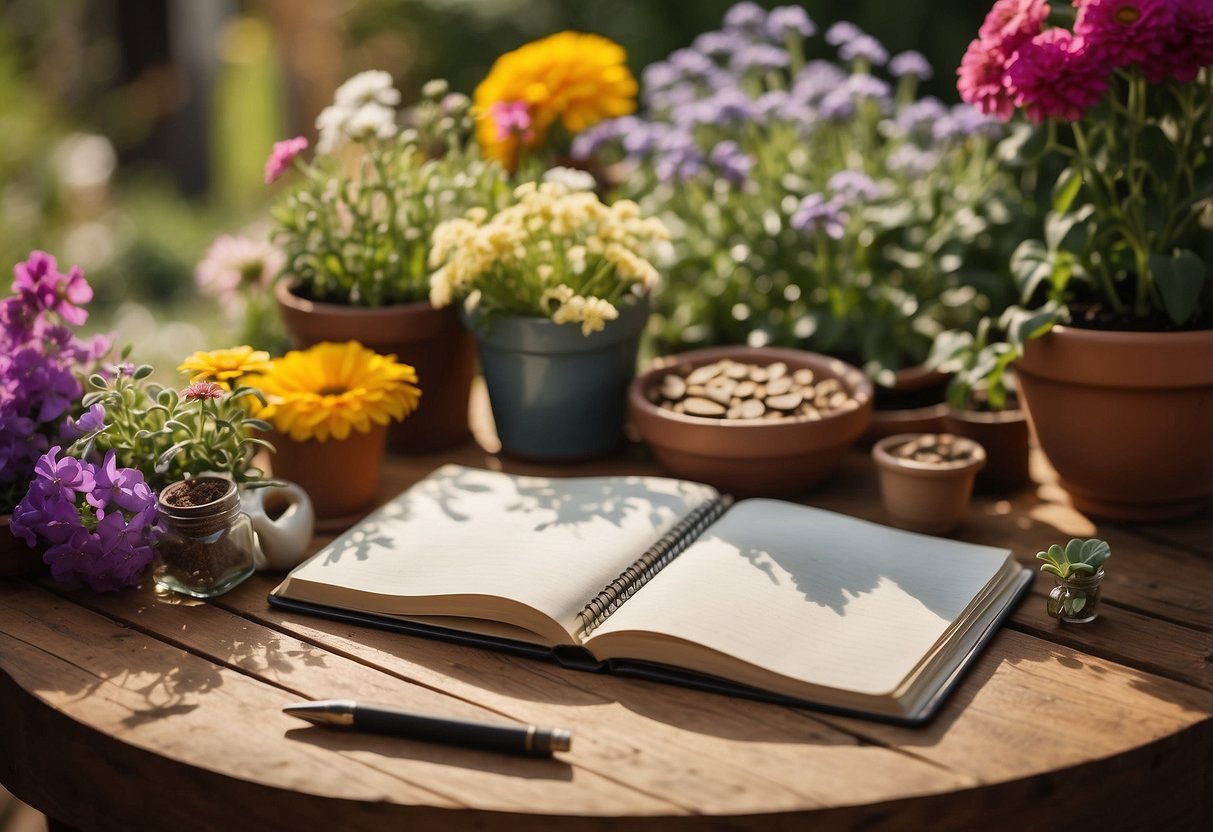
(628, 347, 873, 496)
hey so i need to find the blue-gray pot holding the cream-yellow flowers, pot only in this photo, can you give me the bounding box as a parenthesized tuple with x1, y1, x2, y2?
(463, 298, 649, 462)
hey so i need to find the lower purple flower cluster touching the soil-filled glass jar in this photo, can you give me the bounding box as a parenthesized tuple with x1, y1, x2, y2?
(11, 445, 160, 592)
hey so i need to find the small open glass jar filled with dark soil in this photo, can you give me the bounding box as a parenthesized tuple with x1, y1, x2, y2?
(152, 477, 257, 598)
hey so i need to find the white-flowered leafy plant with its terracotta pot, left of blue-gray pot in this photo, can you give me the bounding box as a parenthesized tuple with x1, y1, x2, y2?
(266, 72, 508, 451)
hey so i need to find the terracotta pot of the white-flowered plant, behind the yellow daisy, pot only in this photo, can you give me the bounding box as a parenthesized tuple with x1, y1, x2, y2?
(274, 281, 475, 454)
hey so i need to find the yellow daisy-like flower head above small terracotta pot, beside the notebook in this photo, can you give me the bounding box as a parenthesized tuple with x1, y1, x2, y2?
(247, 341, 421, 441)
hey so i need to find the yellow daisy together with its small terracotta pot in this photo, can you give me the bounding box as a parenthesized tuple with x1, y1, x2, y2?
(244, 341, 421, 531)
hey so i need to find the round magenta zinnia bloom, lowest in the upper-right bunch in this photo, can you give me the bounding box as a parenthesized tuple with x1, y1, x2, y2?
(1007, 29, 1107, 122)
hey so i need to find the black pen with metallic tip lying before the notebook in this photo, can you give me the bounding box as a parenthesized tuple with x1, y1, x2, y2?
(283, 699, 573, 757)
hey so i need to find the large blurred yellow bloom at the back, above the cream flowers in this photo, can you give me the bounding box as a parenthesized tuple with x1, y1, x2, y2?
(473, 32, 637, 170)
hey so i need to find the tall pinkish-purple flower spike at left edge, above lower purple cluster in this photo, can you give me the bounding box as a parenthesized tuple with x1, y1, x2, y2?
(0, 251, 109, 512)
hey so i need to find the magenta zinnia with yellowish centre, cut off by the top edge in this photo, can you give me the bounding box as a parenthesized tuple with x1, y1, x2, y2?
(1074, 0, 1178, 67)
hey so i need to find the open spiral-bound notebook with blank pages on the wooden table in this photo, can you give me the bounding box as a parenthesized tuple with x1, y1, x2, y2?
(269, 466, 1031, 723)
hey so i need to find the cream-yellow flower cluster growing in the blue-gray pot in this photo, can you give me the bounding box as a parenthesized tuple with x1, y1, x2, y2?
(429, 182, 670, 335)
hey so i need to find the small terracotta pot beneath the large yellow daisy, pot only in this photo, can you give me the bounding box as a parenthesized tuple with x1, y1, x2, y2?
(266, 424, 387, 531)
